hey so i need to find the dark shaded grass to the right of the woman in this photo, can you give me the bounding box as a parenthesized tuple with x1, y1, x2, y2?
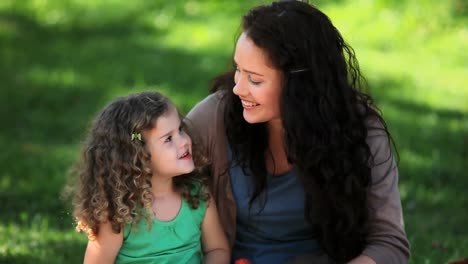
(371, 76, 468, 263)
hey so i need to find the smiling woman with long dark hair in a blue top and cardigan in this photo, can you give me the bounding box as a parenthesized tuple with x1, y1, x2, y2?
(188, 1, 409, 263)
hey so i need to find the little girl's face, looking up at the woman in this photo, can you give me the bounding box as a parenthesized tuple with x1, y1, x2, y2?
(143, 106, 195, 177)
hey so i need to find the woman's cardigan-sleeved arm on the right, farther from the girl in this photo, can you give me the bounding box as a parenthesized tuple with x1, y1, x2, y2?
(362, 123, 410, 263)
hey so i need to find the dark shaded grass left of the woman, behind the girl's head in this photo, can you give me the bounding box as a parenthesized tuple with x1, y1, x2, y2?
(0, 9, 228, 229)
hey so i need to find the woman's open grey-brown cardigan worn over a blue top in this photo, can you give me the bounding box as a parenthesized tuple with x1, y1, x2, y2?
(187, 92, 410, 264)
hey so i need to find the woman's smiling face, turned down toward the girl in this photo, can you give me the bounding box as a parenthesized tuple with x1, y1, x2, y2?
(233, 33, 283, 123)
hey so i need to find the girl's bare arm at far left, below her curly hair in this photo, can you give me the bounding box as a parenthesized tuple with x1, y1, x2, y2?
(83, 222, 123, 264)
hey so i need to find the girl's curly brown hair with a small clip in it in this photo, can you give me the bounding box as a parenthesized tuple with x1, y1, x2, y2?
(66, 92, 209, 239)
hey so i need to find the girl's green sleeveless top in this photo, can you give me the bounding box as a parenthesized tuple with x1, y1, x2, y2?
(115, 195, 206, 264)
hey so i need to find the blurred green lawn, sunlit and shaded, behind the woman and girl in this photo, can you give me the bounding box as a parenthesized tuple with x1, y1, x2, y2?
(0, 0, 468, 264)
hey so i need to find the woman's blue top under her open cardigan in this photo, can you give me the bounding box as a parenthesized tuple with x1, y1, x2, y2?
(228, 147, 319, 264)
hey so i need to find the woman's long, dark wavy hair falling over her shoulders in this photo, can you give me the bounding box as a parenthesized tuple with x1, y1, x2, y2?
(211, 1, 390, 263)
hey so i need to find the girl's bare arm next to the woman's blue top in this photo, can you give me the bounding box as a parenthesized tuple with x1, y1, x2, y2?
(201, 196, 230, 264)
